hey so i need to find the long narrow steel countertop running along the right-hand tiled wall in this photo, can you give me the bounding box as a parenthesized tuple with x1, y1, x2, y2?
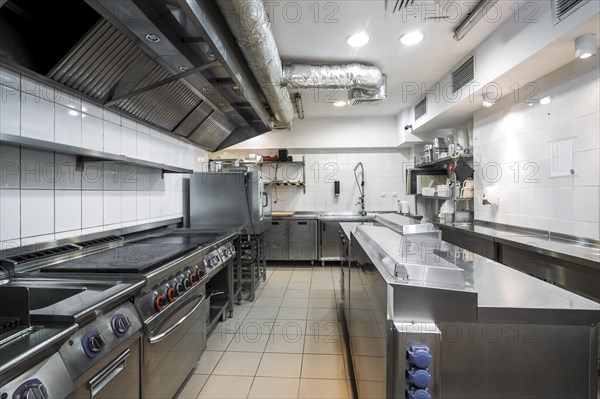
(437, 223, 600, 270)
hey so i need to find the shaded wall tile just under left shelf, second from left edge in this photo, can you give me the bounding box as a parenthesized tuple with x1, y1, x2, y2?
(21, 149, 55, 190)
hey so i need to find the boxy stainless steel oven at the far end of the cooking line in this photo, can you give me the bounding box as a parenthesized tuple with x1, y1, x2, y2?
(190, 171, 269, 234)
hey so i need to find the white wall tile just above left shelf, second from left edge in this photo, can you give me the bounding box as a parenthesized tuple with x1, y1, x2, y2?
(21, 93, 54, 141)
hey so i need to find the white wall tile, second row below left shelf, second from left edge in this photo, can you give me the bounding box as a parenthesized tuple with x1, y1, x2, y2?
(21, 190, 54, 237)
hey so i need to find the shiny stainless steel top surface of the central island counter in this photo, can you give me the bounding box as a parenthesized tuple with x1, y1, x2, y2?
(348, 226, 600, 325)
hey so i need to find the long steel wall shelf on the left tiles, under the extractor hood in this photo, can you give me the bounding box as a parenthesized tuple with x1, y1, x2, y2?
(0, 133, 194, 174)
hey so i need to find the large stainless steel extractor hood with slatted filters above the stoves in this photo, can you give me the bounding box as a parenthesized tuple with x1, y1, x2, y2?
(0, 0, 273, 151)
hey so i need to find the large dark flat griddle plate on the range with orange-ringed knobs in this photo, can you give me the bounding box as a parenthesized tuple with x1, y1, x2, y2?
(42, 242, 197, 273)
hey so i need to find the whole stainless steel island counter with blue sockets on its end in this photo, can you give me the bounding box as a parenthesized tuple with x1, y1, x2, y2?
(341, 225, 600, 399)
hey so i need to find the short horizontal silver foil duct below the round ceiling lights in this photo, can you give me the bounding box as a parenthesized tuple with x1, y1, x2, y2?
(281, 64, 384, 92)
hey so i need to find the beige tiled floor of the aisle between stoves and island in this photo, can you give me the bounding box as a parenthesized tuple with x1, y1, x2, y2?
(179, 266, 352, 399)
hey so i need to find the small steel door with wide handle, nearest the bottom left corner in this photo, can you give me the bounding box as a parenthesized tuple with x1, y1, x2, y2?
(67, 333, 141, 399)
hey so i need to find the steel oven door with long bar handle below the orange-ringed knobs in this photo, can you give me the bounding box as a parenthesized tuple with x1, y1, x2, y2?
(142, 292, 208, 399)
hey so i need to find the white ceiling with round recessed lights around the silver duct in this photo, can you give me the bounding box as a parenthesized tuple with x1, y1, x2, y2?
(265, 0, 523, 118)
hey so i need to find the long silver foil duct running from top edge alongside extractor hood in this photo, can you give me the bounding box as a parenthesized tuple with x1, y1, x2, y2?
(217, 0, 294, 128)
